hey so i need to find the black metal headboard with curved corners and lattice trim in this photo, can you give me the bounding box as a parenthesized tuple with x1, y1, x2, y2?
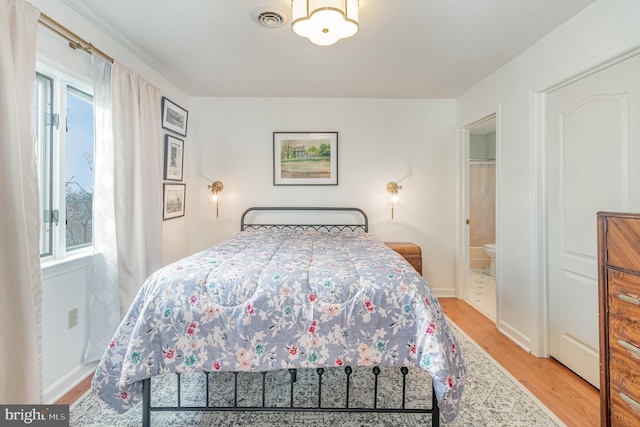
(240, 207, 369, 233)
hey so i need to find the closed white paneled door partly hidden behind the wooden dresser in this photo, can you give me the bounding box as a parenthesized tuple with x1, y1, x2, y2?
(547, 56, 640, 387)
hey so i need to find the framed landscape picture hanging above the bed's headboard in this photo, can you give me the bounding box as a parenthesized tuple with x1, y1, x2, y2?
(273, 132, 338, 185)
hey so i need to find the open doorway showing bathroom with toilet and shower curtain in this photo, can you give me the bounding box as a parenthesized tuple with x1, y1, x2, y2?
(464, 114, 497, 322)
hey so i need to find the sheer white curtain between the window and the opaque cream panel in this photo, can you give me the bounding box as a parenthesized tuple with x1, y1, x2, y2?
(85, 55, 120, 362)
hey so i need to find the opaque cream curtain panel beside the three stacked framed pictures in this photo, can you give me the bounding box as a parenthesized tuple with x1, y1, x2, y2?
(111, 62, 162, 317)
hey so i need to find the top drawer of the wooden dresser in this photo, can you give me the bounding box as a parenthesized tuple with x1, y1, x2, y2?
(606, 217, 640, 271)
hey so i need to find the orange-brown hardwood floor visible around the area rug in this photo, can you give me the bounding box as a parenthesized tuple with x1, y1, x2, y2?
(56, 298, 600, 427)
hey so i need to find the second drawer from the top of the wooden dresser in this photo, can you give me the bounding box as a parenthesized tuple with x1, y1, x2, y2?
(607, 270, 640, 323)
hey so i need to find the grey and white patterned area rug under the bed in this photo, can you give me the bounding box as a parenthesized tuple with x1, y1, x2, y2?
(70, 324, 564, 427)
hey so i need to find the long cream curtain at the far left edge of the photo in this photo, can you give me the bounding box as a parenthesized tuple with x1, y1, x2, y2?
(0, 0, 42, 404)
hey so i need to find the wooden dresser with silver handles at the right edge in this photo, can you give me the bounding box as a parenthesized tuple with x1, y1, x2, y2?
(598, 212, 640, 426)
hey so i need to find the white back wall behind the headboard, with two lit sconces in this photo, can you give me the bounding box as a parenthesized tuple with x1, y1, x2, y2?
(185, 98, 456, 295)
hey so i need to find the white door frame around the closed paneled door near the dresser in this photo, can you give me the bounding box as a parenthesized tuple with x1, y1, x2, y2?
(529, 45, 640, 357)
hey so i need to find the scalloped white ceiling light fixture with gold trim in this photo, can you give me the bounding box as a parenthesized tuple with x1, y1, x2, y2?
(291, 0, 358, 46)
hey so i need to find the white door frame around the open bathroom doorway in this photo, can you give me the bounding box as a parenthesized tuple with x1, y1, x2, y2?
(456, 105, 501, 325)
